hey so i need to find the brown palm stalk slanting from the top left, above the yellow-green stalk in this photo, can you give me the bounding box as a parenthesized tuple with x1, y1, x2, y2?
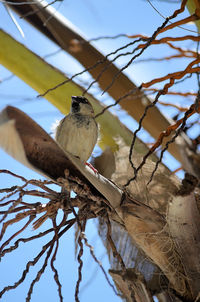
(3, 0, 191, 161)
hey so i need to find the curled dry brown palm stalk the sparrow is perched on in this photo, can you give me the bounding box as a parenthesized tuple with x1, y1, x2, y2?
(0, 106, 194, 295)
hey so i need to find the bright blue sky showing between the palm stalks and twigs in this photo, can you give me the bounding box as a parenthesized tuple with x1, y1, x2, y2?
(0, 0, 198, 302)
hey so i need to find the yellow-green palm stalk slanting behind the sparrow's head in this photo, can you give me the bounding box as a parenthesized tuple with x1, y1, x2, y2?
(0, 30, 158, 162)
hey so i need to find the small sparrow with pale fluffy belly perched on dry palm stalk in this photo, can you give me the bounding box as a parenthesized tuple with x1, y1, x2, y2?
(55, 96, 98, 162)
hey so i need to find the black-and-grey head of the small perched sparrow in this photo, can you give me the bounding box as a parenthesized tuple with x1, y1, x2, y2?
(71, 96, 94, 116)
